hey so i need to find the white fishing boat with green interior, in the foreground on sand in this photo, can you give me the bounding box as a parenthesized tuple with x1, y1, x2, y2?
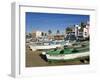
(42, 47, 89, 61)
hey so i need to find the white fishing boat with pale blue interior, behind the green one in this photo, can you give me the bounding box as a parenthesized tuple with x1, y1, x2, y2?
(29, 41, 72, 51)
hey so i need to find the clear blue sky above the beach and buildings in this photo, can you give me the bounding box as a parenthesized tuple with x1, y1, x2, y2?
(26, 12, 89, 34)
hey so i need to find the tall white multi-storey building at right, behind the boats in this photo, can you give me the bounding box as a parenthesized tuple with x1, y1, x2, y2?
(65, 22, 90, 40)
